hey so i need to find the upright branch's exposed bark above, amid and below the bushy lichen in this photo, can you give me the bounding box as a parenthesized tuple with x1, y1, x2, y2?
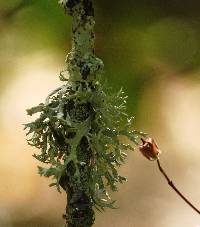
(60, 0, 103, 227)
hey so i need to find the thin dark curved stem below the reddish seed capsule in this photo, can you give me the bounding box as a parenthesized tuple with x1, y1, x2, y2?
(157, 159, 200, 214)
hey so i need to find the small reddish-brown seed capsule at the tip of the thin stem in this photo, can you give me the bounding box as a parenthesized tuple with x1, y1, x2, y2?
(139, 138, 161, 161)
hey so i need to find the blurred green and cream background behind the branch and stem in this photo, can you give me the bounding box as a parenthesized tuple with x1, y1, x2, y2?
(0, 0, 200, 227)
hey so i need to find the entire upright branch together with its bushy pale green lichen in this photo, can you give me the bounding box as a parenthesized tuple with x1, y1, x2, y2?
(25, 0, 144, 227)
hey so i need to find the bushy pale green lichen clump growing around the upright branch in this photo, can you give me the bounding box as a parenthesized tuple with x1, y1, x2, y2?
(26, 78, 144, 209)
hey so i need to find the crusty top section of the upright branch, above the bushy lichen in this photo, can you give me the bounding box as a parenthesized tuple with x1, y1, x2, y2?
(60, 0, 103, 82)
